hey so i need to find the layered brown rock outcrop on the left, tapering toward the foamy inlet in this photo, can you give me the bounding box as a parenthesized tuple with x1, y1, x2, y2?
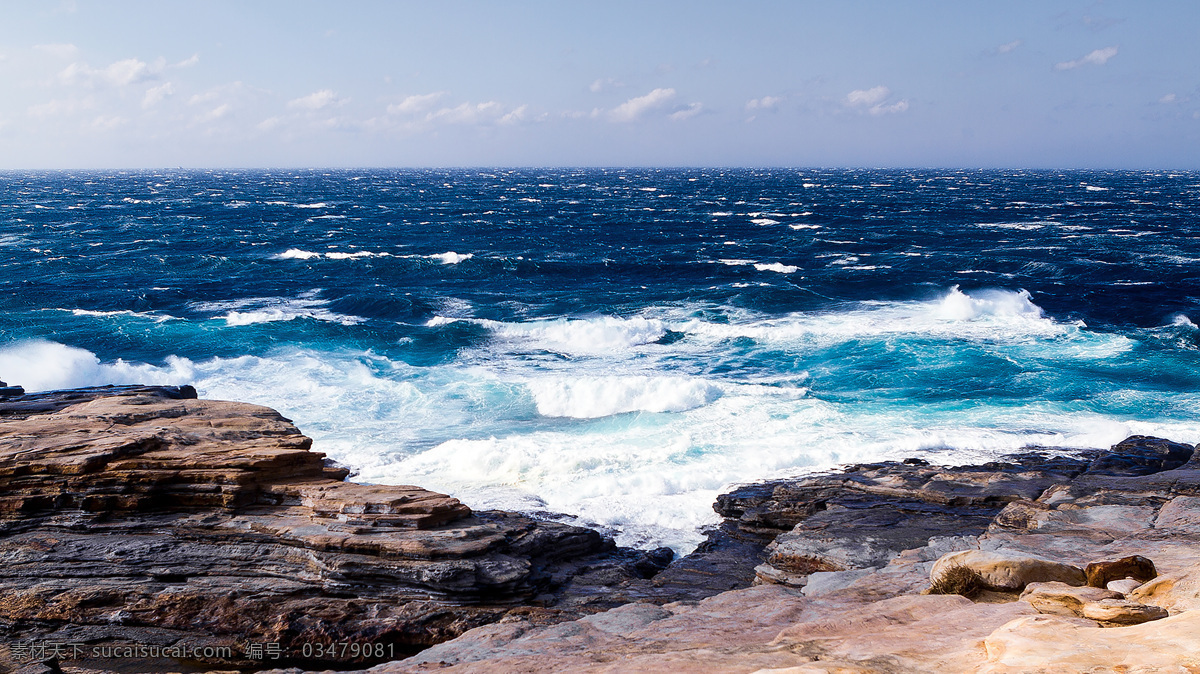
(0, 386, 676, 670)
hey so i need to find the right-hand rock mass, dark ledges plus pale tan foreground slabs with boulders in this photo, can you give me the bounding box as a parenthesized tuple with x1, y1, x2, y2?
(372, 437, 1200, 674)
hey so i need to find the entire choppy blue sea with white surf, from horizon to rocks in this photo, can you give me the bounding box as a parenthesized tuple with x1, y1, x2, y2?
(0, 169, 1200, 550)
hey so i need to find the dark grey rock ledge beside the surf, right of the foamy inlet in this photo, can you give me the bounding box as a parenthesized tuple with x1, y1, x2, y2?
(734, 453, 1087, 586)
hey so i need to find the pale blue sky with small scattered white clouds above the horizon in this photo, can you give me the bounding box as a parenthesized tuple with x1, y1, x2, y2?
(0, 0, 1200, 169)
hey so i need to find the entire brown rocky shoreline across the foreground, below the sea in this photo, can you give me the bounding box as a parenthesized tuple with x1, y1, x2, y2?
(0, 386, 1200, 674)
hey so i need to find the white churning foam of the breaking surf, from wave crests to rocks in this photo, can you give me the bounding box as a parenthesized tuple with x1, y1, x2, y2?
(0, 331, 1200, 552)
